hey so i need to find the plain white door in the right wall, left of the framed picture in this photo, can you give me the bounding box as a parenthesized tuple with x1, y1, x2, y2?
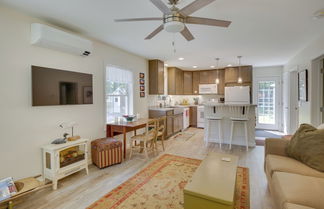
(283, 71, 299, 134)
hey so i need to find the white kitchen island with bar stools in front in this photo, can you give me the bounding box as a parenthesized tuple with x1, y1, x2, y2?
(204, 102, 256, 147)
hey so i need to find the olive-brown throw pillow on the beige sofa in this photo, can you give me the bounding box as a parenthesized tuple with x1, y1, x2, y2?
(286, 124, 324, 172)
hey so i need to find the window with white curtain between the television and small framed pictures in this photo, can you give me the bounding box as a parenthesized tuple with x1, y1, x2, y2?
(106, 66, 133, 122)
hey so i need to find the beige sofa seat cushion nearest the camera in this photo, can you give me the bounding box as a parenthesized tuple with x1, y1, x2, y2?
(272, 172, 324, 209)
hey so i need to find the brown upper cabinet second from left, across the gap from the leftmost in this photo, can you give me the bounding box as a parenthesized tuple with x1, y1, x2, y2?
(168, 67, 184, 95)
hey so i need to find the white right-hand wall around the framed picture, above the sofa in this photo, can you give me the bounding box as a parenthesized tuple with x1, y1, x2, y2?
(284, 34, 324, 125)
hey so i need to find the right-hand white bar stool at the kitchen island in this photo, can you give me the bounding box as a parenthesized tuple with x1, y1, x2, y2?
(229, 106, 250, 151)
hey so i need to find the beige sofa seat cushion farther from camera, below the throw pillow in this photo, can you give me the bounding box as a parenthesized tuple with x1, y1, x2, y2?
(266, 155, 324, 178)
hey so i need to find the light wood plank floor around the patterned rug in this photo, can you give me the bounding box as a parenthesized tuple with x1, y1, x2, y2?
(15, 128, 275, 209)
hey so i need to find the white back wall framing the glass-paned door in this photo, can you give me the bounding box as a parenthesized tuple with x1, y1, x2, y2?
(253, 66, 283, 130)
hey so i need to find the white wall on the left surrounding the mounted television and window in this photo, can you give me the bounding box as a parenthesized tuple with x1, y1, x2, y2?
(0, 7, 148, 179)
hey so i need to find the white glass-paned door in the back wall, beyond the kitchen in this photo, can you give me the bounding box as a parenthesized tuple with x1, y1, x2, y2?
(256, 77, 280, 130)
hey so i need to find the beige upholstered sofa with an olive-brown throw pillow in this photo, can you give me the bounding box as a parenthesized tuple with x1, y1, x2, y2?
(264, 139, 324, 209)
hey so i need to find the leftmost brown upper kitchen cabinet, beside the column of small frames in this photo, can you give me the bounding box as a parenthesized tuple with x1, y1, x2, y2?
(149, 60, 164, 94)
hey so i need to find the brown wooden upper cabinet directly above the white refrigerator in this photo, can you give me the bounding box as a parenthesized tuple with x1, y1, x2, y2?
(225, 66, 252, 84)
